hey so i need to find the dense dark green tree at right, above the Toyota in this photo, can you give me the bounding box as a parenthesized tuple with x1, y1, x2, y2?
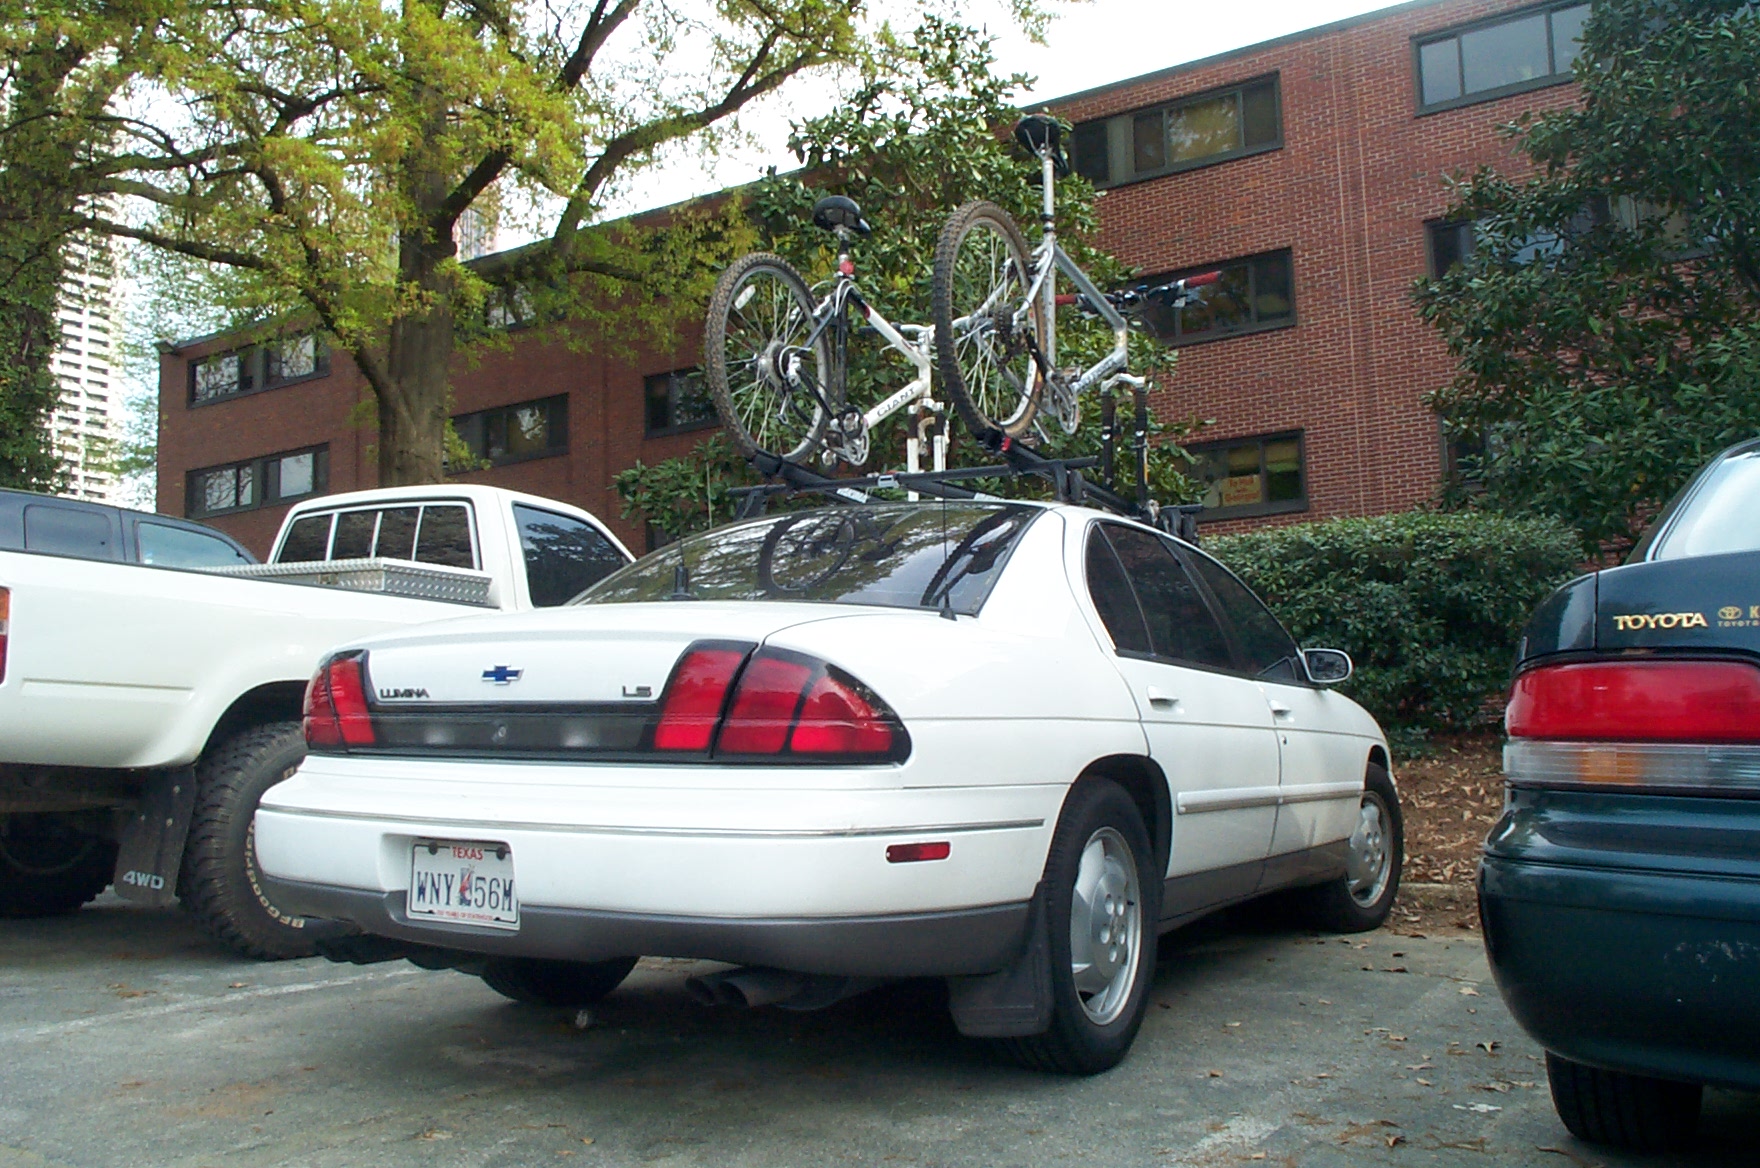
(1417, 0, 1760, 551)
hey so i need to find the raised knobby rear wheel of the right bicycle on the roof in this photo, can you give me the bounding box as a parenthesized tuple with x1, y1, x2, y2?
(929, 199, 1045, 438)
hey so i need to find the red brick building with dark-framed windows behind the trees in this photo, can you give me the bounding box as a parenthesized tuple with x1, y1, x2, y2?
(158, 0, 1589, 552)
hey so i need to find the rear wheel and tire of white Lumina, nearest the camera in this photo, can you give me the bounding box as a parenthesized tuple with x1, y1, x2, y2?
(1005, 779, 1162, 1075)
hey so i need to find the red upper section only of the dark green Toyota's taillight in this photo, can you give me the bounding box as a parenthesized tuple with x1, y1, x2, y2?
(1503, 661, 1760, 742)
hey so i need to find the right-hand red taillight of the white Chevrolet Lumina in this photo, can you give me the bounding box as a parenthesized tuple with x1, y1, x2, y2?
(653, 642, 910, 762)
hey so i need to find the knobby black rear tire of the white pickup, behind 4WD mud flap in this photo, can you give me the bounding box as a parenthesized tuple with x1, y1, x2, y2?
(178, 721, 317, 960)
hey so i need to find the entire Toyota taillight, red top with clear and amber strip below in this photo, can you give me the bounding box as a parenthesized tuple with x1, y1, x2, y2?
(1503, 661, 1760, 795)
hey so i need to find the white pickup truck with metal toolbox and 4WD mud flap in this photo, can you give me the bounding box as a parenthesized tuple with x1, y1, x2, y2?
(0, 485, 630, 959)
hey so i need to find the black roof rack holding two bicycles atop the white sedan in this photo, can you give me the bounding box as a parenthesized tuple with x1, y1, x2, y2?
(729, 419, 1202, 545)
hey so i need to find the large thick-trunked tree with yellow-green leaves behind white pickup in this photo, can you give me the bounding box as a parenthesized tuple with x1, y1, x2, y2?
(51, 0, 978, 484)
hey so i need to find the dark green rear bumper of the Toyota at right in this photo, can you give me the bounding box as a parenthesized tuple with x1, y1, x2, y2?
(1478, 834, 1760, 1091)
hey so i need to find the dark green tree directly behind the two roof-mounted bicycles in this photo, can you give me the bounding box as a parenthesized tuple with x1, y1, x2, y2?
(618, 16, 1197, 535)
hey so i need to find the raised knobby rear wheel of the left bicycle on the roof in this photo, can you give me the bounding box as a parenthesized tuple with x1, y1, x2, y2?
(702, 252, 841, 463)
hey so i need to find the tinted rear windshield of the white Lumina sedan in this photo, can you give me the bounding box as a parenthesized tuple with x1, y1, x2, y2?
(572, 503, 1040, 616)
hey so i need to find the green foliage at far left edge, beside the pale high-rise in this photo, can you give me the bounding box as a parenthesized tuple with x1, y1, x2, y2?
(0, 0, 164, 491)
